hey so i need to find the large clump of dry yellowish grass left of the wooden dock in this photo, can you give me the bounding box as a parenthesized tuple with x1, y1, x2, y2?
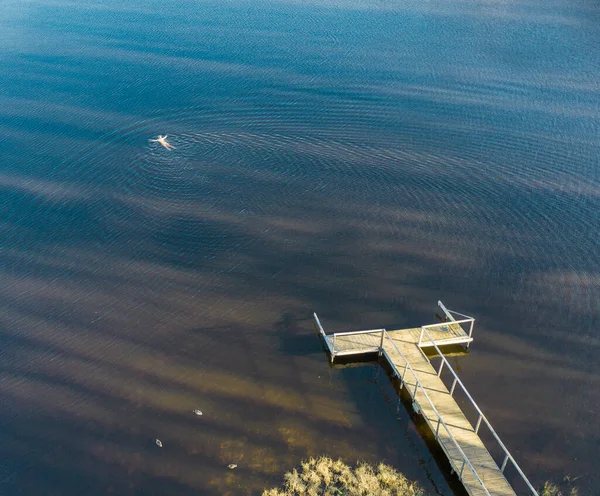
(262, 456, 424, 496)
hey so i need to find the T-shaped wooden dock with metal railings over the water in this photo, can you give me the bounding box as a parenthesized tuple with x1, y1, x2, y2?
(314, 302, 538, 496)
